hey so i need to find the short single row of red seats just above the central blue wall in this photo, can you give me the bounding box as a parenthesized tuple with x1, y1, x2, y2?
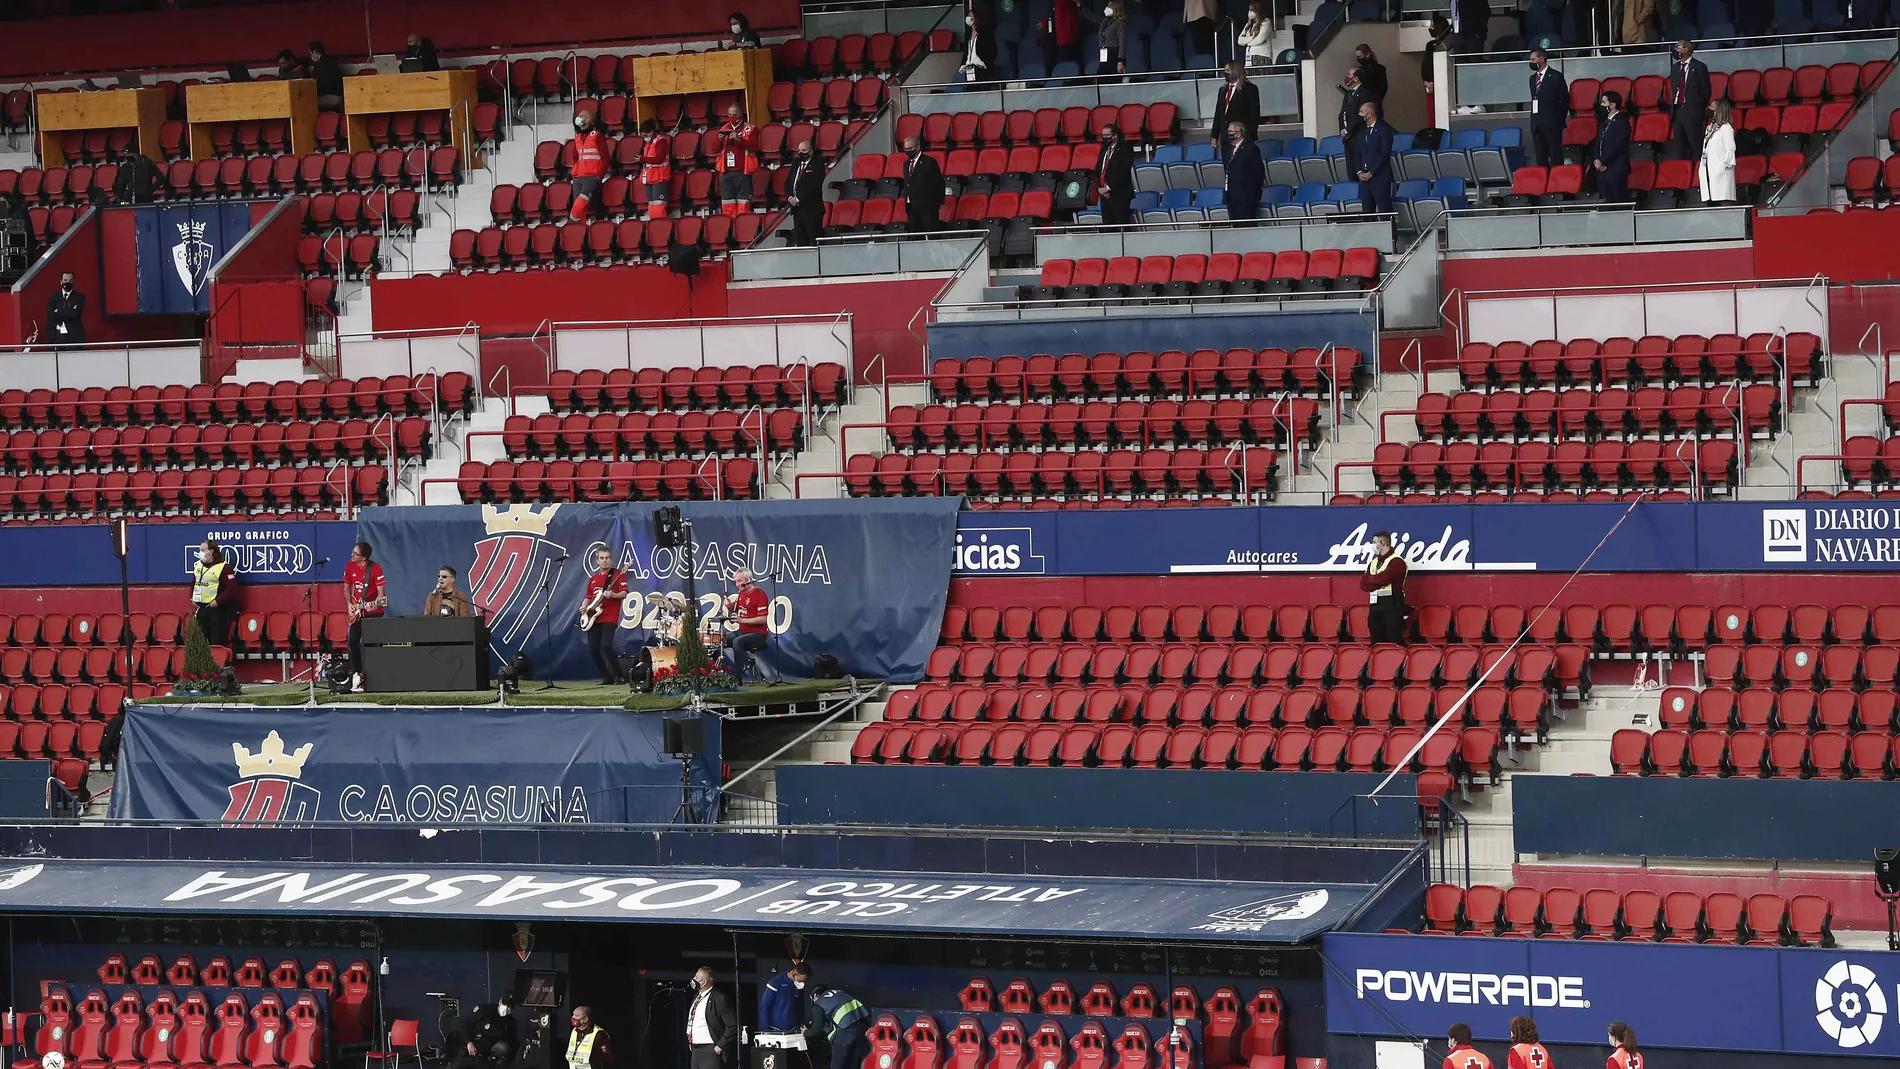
(1022, 249, 1379, 300)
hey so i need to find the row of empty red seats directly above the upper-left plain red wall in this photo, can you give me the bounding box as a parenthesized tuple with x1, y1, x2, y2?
(448, 215, 777, 272)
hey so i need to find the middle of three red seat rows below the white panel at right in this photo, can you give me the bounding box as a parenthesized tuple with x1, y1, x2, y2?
(1414, 382, 1782, 442)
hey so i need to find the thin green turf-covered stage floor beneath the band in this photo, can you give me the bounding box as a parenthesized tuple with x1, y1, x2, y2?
(141, 680, 862, 712)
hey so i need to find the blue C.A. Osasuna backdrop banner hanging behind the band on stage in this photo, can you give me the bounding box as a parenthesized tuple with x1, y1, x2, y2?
(357, 497, 960, 680)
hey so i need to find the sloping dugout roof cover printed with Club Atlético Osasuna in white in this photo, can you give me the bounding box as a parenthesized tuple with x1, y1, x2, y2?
(0, 858, 1370, 944)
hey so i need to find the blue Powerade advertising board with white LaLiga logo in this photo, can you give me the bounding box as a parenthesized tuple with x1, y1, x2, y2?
(1322, 934, 1900, 1058)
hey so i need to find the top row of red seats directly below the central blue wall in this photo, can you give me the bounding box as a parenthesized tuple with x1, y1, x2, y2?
(929, 349, 1364, 403)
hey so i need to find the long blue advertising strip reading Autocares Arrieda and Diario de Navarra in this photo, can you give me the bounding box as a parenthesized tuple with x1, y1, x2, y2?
(954, 501, 1900, 575)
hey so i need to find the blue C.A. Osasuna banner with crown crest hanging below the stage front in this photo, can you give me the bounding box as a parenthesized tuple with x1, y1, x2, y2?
(112, 704, 720, 826)
